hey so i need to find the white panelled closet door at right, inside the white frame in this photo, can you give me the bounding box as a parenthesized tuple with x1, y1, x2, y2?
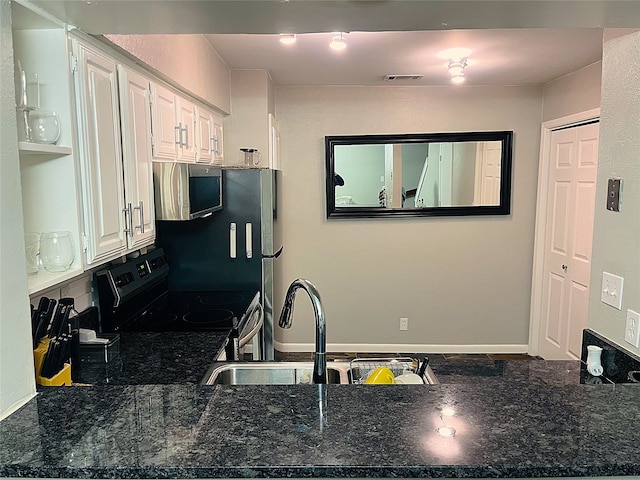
(539, 123, 599, 359)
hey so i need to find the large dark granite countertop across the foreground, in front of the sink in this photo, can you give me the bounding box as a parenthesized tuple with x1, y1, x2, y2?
(0, 361, 640, 478)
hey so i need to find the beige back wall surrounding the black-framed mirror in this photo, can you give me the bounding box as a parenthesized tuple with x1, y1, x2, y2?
(276, 87, 542, 352)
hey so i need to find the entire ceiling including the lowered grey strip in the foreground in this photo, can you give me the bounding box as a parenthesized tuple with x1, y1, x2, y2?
(25, 0, 640, 85)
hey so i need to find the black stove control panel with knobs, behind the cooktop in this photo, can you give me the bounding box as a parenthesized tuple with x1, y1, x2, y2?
(96, 248, 169, 308)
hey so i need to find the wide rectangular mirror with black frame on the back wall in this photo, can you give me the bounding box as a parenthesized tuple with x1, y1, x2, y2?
(325, 131, 513, 218)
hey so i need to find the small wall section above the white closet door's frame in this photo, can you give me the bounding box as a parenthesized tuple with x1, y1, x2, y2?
(542, 62, 602, 122)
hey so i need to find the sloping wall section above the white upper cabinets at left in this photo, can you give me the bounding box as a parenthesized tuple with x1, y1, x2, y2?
(105, 35, 230, 113)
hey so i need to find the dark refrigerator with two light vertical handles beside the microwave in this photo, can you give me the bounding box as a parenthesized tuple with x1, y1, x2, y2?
(156, 168, 283, 360)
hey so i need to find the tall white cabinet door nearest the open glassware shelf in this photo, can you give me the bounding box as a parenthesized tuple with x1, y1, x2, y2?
(74, 41, 126, 264)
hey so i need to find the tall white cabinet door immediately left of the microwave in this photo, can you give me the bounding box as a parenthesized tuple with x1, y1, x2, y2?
(118, 65, 155, 249)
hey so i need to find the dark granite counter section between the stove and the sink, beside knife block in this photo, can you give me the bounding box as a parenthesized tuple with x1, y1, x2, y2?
(73, 332, 229, 385)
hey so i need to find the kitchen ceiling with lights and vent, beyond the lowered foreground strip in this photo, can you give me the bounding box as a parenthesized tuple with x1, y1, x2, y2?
(206, 28, 602, 85)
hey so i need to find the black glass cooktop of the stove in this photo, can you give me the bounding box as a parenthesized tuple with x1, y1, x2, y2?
(120, 291, 256, 332)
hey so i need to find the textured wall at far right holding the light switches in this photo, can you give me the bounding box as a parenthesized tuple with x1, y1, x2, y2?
(588, 30, 640, 354)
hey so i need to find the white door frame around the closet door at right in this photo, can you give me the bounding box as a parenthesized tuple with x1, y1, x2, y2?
(529, 108, 600, 355)
